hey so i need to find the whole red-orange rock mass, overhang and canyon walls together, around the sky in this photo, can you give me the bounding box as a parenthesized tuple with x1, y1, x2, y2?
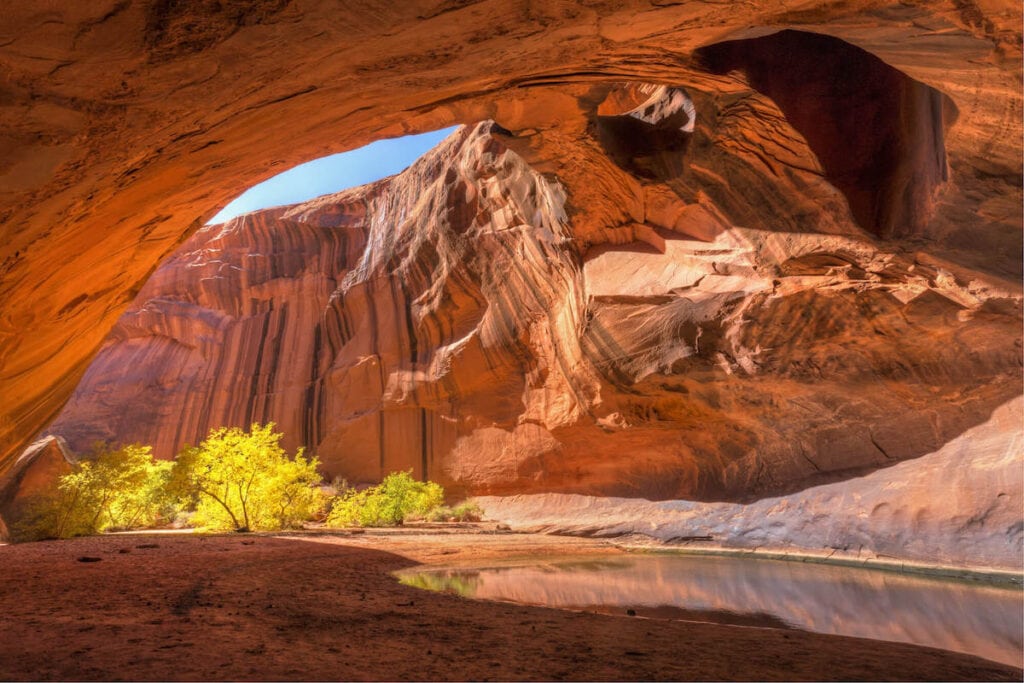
(0, 0, 1022, 528)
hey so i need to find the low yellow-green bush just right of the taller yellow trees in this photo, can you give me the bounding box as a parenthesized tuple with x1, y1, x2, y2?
(327, 470, 444, 526)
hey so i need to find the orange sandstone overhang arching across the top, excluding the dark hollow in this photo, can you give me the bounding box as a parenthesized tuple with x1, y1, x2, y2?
(0, 0, 1021, 499)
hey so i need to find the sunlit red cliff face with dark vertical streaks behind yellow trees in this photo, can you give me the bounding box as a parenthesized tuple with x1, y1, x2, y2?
(51, 124, 599, 483)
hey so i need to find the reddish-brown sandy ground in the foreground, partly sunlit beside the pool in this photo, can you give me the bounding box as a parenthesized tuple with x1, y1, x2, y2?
(0, 532, 1022, 681)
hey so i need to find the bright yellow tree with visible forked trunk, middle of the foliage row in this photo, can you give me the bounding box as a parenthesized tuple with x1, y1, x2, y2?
(171, 423, 324, 531)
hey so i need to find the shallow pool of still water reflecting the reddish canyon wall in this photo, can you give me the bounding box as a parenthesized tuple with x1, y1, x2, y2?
(401, 555, 1024, 667)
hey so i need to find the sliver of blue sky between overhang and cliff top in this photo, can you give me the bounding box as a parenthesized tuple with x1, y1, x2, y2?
(210, 126, 458, 223)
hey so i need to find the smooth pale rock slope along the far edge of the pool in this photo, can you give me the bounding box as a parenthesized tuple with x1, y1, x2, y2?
(477, 398, 1024, 572)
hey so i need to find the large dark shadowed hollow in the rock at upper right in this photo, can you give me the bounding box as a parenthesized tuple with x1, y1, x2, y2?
(695, 31, 957, 238)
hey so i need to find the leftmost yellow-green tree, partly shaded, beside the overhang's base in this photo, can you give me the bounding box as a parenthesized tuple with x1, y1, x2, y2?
(14, 444, 174, 540)
